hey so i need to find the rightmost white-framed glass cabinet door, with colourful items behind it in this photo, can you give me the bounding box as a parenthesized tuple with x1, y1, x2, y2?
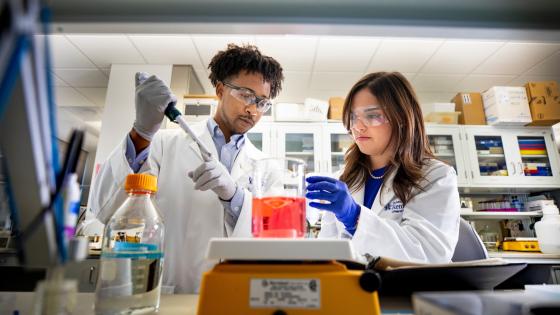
(509, 128, 559, 185)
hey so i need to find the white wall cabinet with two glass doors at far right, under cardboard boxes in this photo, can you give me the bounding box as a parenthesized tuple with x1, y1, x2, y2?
(463, 126, 560, 188)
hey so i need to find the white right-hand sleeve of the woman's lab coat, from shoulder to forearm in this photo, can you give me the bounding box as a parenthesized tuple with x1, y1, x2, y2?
(352, 164, 460, 263)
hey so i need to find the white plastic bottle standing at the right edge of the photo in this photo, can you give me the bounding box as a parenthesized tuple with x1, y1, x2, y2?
(535, 205, 560, 254)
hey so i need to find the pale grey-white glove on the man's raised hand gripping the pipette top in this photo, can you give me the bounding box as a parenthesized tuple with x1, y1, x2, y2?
(133, 72, 177, 141)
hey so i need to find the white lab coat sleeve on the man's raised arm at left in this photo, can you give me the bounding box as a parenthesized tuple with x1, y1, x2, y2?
(89, 133, 161, 224)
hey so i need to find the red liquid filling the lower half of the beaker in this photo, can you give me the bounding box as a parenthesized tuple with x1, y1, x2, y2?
(252, 197, 305, 238)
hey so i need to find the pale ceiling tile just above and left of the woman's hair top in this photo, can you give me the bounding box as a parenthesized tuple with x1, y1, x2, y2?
(313, 36, 380, 73)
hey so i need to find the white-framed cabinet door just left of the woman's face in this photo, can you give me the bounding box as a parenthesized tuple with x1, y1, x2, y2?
(323, 123, 354, 174)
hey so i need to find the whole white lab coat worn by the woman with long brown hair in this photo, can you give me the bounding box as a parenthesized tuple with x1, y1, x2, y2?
(319, 160, 460, 263)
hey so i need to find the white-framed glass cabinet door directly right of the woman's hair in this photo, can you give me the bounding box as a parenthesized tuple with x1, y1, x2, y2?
(426, 126, 468, 186)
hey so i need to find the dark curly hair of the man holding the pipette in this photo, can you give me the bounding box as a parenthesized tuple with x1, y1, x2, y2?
(208, 44, 284, 98)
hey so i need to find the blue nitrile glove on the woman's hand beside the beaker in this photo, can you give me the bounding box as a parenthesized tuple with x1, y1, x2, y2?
(305, 176, 360, 234)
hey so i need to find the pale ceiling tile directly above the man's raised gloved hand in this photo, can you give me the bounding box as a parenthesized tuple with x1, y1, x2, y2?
(129, 35, 204, 68)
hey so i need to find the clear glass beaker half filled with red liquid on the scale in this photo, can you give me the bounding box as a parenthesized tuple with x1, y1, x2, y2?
(251, 158, 305, 238)
